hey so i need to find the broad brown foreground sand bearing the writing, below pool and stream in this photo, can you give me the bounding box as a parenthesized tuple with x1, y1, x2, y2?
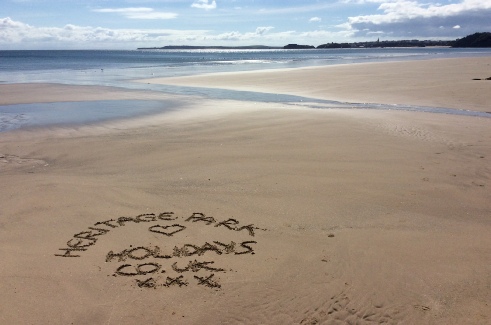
(0, 60, 491, 324)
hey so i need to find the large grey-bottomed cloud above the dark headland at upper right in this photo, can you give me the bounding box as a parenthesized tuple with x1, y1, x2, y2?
(344, 0, 491, 37)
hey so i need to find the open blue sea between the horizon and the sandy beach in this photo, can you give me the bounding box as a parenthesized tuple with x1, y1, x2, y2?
(0, 48, 491, 85)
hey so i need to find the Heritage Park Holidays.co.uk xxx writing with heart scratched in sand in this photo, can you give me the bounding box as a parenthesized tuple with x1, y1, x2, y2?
(54, 212, 266, 289)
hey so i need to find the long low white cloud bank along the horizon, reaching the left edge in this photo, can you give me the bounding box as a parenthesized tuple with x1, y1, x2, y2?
(0, 17, 360, 49)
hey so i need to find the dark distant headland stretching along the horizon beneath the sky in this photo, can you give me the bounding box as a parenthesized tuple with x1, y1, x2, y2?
(138, 32, 491, 50)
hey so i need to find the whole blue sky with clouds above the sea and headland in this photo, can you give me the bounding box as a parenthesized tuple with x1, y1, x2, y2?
(0, 0, 491, 50)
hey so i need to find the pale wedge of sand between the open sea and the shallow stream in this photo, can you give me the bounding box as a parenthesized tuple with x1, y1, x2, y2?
(138, 57, 491, 112)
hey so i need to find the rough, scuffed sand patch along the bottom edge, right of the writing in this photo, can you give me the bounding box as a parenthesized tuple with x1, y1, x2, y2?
(215, 274, 420, 325)
